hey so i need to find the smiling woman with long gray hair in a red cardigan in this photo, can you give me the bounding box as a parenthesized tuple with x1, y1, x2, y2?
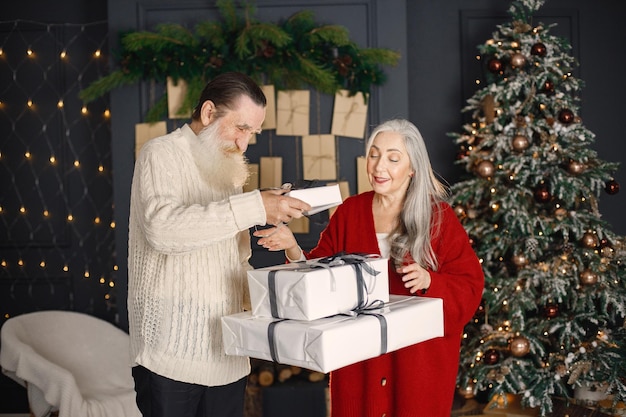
(255, 120, 484, 417)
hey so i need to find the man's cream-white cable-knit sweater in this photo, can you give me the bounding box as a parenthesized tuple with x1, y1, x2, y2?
(128, 125, 266, 386)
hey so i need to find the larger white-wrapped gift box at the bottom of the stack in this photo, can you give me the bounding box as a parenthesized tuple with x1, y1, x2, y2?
(222, 295, 443, 373)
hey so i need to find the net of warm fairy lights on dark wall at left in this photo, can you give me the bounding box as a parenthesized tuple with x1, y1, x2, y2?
(0, 20, 117, 320)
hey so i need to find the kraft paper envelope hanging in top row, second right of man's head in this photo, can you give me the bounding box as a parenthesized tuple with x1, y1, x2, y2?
(276, 90, 311, 136)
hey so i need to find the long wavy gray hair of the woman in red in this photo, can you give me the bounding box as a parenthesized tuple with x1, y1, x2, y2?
(366, 119, 448, 271)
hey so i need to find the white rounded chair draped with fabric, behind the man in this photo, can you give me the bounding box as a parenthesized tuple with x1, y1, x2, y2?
(0, 311, 141, 417)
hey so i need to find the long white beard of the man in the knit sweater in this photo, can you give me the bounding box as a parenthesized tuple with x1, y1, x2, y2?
(194, 120, 249, 191)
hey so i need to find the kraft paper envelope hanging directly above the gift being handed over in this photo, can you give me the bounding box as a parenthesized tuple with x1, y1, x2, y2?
(302, 135, 337, 180)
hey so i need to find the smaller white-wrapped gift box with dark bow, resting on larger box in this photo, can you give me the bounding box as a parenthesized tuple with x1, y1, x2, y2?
(248, 255, 389, 320)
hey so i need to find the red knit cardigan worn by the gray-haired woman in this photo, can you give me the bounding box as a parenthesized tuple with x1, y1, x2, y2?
(306, 191, 484, 417)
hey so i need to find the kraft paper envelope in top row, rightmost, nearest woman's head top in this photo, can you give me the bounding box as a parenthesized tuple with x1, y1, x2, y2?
(330, 90, 367, 139)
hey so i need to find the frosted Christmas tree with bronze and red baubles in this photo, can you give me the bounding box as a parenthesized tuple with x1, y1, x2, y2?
(450, 0, 626, 416)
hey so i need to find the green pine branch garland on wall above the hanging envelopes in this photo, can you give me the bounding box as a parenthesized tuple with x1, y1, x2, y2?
(80, 0, 400, 122)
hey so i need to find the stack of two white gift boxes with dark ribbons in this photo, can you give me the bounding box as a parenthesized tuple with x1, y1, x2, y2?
(222, 254, 443, 373)
